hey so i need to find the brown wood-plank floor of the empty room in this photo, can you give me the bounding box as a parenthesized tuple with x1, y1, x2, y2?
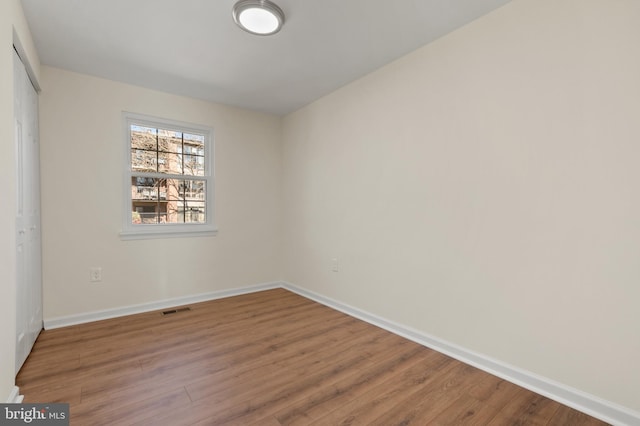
(17, 289, 604, 426)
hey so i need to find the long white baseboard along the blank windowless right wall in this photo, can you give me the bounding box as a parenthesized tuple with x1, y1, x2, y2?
(282, 283, 640, 426)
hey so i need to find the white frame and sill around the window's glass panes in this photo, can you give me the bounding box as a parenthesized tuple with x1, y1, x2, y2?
(120, 112, 217, 240)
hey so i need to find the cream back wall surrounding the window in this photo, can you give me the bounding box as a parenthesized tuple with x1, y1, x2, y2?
(40, 66, 282, 321)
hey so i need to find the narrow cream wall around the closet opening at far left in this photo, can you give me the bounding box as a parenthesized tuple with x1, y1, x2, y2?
(0, 0, 40, 402)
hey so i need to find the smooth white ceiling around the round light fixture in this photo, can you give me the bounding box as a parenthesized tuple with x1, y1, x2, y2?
(22, 0, 511, 114)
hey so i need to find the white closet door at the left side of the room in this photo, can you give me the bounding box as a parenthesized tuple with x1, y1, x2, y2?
(13, 48, 42, 373)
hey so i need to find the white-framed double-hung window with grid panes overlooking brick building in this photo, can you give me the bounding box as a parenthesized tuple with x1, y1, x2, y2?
(120, 113, 215, 239)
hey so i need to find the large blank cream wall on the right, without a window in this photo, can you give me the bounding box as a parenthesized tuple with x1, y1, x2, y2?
(283, 0, 640, 411)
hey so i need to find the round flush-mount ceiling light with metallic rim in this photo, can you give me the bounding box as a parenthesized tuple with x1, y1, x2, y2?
(233, 0, 284, 35)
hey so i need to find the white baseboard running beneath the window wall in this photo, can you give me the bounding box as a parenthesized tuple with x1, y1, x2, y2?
(44, 282, 282, 330)
